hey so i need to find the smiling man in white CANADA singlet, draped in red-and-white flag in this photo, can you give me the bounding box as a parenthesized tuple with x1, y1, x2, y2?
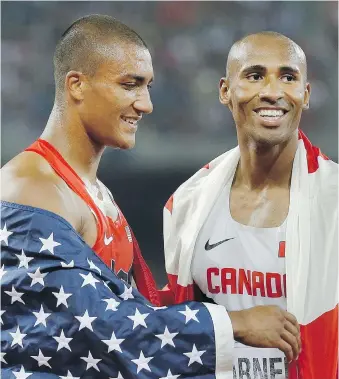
(164, 32, 338, 379)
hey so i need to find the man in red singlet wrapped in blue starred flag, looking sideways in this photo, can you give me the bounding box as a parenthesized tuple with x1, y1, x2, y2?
(0, 15, 293, 379)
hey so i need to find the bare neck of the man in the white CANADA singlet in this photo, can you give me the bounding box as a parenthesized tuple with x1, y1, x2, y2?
(234, 131, 298, 190)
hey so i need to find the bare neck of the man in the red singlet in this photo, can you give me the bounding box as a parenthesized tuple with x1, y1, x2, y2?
(40, 105, 105, 183)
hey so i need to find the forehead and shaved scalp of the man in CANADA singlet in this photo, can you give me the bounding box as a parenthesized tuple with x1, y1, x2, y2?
(226, 35, 307, 79)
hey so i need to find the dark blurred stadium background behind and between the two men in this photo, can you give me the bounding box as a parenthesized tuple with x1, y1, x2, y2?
(1, 1, 338, 285)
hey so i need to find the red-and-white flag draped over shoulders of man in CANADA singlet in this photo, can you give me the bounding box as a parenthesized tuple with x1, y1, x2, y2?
(164, 131, 338, 379)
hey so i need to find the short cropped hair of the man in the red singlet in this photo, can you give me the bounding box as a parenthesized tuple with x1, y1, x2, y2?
(53, 14, 148, 94)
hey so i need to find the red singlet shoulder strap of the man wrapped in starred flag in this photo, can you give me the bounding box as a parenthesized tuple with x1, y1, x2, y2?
(25, 138, 106, 240)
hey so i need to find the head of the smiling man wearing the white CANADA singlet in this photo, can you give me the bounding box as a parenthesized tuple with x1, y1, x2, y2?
(226, 32, 310, 148)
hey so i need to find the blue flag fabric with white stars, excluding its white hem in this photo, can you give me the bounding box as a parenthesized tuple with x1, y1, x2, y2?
(0, 202, 216, 379)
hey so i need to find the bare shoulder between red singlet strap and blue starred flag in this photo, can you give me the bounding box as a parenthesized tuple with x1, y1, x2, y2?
(1, 151, 81, 230)
